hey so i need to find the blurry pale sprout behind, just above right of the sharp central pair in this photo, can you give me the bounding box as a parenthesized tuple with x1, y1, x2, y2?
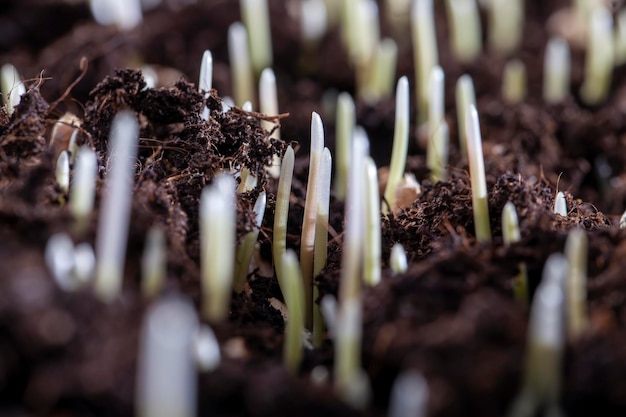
(334, 93, 356, 200)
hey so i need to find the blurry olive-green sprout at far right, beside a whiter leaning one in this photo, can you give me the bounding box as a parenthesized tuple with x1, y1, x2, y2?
(565, 229, 587, 340)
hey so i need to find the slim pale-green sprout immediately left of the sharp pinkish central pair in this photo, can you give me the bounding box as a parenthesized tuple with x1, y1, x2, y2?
(272, 146, 294, 294)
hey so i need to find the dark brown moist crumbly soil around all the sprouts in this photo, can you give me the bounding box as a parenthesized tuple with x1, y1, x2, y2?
(0, 0, 626, 416)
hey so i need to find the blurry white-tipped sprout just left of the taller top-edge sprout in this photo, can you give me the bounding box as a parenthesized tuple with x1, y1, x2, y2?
(228, 22, 254, 107)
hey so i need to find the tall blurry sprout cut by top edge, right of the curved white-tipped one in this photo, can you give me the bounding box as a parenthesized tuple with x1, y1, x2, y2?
(411, 0, 439, 126)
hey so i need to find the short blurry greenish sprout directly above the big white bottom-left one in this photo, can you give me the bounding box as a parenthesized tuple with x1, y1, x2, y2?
(141, 226, 167, 298)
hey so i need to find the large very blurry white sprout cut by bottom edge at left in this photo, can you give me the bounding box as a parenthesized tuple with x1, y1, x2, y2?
(135, 297, 198, 417)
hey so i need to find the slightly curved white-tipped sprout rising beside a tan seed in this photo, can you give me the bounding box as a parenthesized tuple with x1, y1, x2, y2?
(382, 76, 410, 214)
